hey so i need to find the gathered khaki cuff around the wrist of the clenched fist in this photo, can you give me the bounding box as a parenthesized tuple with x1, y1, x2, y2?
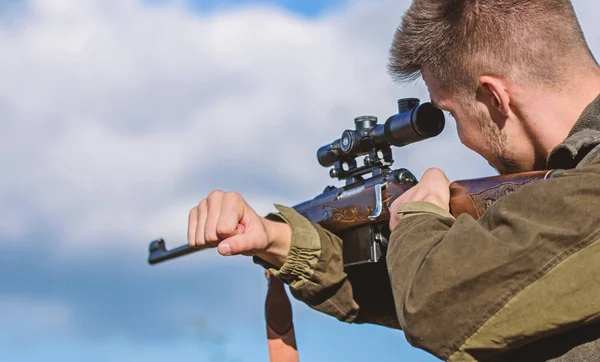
(254, 204, 321, 288)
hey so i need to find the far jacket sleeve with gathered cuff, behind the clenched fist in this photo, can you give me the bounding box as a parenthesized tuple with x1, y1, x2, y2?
(254, 205, 399, 328)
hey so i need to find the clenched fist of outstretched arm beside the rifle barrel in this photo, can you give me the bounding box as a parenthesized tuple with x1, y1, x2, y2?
(188, 190, 291, 267)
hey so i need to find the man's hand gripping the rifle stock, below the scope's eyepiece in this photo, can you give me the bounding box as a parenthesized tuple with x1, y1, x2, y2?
(390, 168, 450, 230)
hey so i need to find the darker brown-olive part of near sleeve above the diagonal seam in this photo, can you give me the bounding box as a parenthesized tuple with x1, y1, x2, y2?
(387, 163, 600, 359)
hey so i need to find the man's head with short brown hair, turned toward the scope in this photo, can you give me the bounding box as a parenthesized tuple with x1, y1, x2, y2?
(389, 0, 598, 173)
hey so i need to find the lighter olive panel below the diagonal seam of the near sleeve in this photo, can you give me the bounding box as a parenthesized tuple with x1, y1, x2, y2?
(448, 238, 600, 362)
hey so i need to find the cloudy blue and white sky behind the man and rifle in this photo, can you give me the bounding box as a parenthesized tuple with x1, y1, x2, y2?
(0, 0, 600, 362)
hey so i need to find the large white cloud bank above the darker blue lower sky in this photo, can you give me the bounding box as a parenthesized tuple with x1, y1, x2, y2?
(0, 0, 600, 258)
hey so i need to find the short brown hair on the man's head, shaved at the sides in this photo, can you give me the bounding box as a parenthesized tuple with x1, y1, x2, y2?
(389, 0, 597, 91)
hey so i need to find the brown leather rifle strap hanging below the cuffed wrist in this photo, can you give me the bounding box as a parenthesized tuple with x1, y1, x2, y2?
(265, 271, 299, 362)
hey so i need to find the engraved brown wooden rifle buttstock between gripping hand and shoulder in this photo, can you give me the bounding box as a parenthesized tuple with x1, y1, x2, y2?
(450, 171, 552, 219)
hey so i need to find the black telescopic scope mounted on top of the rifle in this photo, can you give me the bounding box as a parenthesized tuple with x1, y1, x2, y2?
(317, 98, 445, 167)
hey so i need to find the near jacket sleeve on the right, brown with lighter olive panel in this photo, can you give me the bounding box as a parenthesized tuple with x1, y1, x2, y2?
(387, 166, 600, 361)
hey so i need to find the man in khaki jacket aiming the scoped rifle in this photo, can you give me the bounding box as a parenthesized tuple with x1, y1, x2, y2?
(188, 0, 600, 361)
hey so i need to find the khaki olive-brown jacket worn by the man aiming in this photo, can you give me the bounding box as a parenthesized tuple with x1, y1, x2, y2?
(255, 96, 600, 362)
